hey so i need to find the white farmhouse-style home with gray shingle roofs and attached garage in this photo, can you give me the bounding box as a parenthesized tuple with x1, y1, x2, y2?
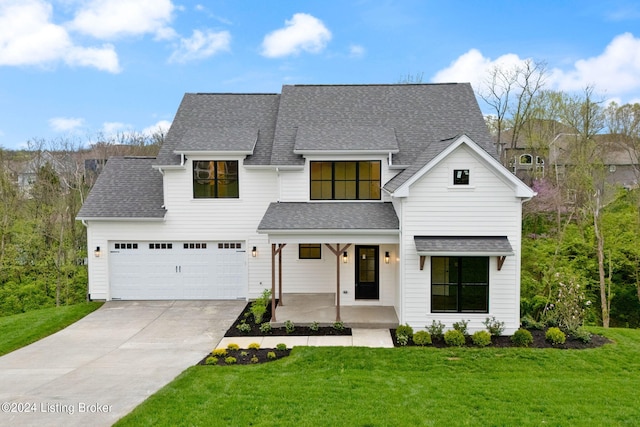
(78, 84, 534, 333)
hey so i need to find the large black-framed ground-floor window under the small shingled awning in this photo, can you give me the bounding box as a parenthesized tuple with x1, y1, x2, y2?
(431, 257, 489, 313)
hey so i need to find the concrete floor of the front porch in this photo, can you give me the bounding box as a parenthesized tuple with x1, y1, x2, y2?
(273, 293, 398, 329)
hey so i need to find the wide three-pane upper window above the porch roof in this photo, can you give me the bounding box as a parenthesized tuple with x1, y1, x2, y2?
(311, 160, 381, 200)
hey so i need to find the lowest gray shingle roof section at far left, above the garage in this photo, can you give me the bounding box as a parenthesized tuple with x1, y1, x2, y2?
(76, 157, 166, 219)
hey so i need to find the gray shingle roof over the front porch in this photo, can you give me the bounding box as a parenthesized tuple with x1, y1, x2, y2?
(258, 202, 399, 231)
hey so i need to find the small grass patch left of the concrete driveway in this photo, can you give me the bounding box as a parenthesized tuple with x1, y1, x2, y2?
(0, 302, 102, 356)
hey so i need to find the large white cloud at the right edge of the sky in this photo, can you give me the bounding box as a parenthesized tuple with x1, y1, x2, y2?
(551, 33, 640, 95)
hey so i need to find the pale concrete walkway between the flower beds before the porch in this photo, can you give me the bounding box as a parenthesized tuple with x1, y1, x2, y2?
(216, 329, 393, 348)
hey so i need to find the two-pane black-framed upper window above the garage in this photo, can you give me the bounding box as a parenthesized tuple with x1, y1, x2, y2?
(193, 160, 240, 199)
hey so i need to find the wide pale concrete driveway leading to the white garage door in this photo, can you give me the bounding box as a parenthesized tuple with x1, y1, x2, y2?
(0, 301, 246, 427)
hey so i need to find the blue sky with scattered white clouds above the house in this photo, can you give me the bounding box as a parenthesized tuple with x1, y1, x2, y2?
(0, 0, 640, 149)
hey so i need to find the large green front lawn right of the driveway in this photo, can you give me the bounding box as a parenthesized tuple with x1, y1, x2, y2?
(118, 329, 640, 426)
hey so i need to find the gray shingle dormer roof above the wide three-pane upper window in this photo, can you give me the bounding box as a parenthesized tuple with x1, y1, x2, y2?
(294, 125, 398, 153)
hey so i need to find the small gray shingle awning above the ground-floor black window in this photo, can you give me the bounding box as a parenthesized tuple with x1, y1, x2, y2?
(413, 236, 513, 256)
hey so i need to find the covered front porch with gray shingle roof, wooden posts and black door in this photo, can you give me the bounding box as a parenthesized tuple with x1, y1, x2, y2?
(258, 202, 399, 328)
